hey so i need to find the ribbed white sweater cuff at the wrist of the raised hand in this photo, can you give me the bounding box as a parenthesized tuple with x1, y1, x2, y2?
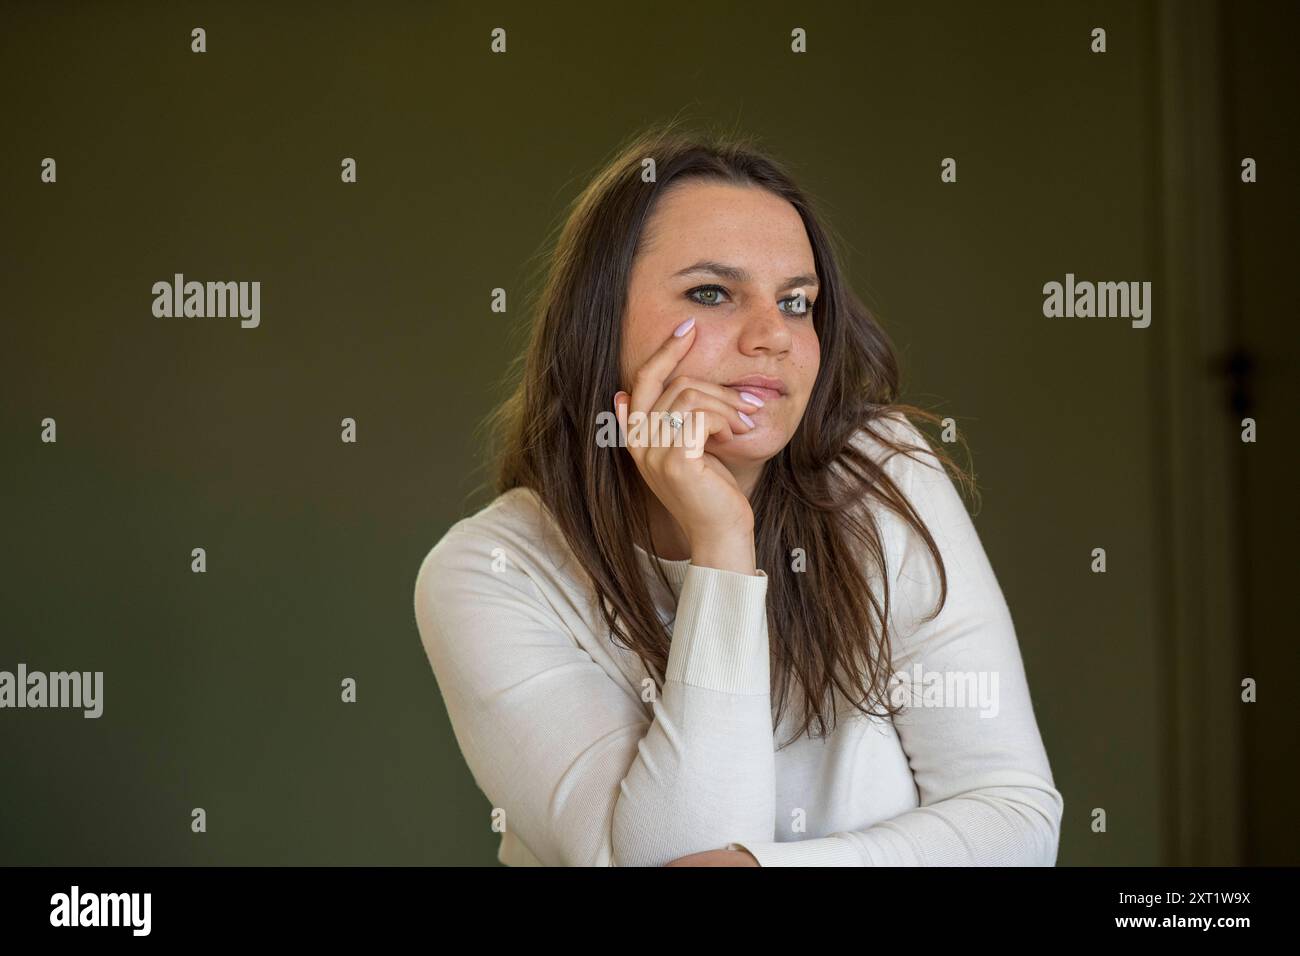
(664, 564, 772, 695)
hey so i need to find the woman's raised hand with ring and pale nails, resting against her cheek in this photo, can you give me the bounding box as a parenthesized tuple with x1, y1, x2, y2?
(614, 317, 758, 574)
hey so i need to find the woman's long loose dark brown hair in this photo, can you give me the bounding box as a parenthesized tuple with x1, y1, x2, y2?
(490, 122, 974, 747)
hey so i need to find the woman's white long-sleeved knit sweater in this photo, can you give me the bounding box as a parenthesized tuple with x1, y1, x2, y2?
(415, 416, 1063, 866)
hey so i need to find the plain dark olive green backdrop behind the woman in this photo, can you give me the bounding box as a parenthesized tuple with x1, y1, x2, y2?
(0, 1, 1300, 865)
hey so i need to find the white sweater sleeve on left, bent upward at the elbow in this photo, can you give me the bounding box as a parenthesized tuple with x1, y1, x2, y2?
(415, 529, 775, 866)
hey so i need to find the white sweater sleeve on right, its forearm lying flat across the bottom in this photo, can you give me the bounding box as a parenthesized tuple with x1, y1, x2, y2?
(731, 429, 1065, 866)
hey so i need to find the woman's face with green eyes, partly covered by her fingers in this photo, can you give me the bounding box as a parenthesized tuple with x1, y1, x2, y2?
(621, 181, 820, 467)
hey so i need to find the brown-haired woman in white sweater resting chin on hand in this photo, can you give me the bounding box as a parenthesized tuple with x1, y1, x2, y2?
(415, 127, 1063, 866)
